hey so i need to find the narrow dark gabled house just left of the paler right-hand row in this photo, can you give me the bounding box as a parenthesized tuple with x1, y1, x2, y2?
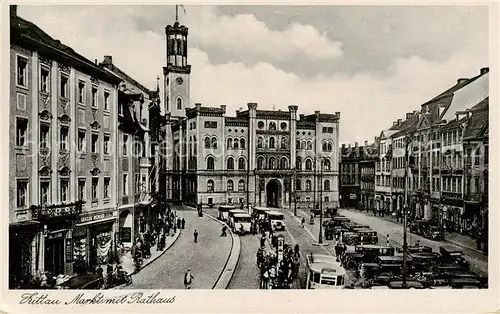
(359, 137, 379, 211)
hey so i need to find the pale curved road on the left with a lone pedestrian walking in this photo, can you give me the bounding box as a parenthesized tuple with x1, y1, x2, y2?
(121, 210, 231, 289)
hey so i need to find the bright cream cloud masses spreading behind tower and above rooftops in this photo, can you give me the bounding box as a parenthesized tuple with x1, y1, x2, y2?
(19, 6, 488, 142)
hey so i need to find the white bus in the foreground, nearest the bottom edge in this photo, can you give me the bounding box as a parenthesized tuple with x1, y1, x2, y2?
(306, 253, 346, 289)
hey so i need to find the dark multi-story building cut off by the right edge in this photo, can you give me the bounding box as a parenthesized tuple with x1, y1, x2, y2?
(460, 98, 489, 253)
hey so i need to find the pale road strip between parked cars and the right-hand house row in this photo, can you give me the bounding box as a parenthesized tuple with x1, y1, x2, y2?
(338, 209, 488, 276)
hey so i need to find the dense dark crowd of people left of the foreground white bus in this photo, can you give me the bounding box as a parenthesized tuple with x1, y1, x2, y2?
(257, 234, 300, 289)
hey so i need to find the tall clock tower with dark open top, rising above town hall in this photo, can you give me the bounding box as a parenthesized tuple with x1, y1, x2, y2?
(163, 17, 191, 118)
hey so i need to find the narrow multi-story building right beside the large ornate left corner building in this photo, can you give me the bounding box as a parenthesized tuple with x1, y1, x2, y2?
(99, 56, 158, 247)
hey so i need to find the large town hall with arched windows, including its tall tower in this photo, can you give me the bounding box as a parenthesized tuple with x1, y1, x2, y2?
(162, 18, 340, 208)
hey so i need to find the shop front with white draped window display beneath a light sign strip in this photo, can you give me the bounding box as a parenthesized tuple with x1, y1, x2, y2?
(73, 209, 117, 272)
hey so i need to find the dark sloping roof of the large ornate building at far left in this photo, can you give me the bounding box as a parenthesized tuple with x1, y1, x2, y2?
(10, 15, 119, 84)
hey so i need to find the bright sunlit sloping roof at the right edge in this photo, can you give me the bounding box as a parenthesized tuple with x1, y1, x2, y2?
(443, 72, 489, 120)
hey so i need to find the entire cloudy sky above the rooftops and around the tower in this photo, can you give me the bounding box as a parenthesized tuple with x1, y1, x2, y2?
(18, 5, 489, 143)
